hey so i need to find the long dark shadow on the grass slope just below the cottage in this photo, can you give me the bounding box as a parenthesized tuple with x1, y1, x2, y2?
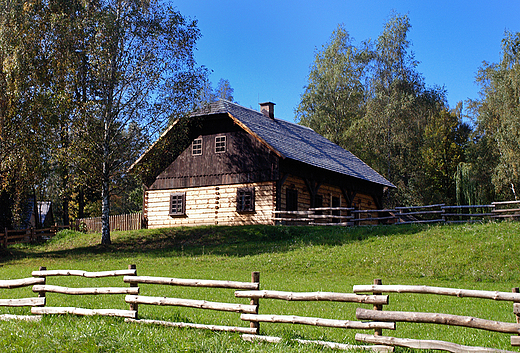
(0, 225, 428, 262)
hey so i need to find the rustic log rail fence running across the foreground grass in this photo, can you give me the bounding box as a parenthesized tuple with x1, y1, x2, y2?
(0, 265, 520, 353)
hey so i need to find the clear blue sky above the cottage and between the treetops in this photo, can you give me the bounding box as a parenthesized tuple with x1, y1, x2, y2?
(172, 0, 520, 121)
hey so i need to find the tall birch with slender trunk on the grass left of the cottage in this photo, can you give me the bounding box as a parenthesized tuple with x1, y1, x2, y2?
(78, 0, 205, 244)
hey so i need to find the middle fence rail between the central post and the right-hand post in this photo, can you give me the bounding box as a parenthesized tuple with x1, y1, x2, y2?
(240, 314, 395, 330)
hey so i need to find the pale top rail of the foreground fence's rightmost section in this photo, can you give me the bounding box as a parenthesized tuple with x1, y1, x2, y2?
(353, 285, 520, 302)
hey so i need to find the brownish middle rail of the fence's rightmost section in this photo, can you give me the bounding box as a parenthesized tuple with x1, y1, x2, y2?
(356, 308, 520, 334)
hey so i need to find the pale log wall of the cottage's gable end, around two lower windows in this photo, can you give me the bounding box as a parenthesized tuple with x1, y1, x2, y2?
(144, 182, 275, 228)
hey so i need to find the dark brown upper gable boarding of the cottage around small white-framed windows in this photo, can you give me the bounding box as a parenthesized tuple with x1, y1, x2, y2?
(150, 116, 278, 190)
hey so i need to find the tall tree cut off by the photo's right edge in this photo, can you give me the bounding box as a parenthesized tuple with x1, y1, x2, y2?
(471, 32, 520, 199)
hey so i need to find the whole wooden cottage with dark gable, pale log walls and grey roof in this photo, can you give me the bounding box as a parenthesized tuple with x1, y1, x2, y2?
(130, 100, 394, 228)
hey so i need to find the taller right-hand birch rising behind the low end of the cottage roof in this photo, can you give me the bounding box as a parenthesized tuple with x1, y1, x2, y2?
(355, 14, 445, 206)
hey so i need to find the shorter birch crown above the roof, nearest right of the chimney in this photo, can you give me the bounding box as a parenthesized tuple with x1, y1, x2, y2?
(295, 25, 369, 149)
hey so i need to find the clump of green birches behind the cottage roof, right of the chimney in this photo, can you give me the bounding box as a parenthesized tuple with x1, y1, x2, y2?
(296, 14, 460, 207)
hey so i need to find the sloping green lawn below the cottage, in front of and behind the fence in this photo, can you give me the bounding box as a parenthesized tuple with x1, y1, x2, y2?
(0, 222, 520, 352)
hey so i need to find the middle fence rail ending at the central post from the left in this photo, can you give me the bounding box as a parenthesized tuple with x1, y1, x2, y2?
(125, 295, 258, 314)
